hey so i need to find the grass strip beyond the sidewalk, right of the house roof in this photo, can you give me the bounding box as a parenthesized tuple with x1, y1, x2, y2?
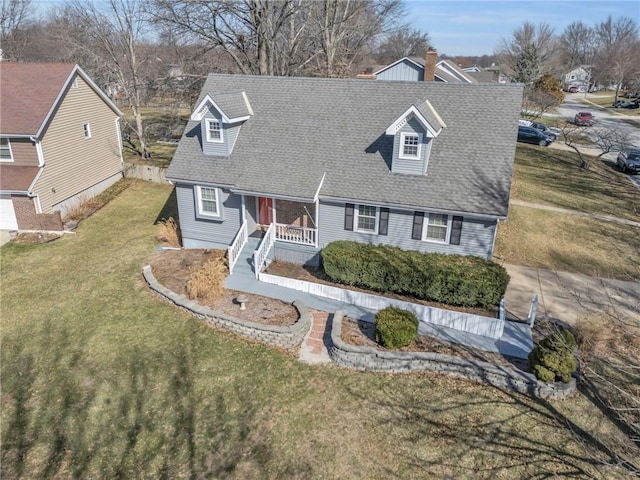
(511, 145, 640, 222)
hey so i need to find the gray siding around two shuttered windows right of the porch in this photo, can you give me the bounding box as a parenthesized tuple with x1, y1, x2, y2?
(319, 201, 496, 258)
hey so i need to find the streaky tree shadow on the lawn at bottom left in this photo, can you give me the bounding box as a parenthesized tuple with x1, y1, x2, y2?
(0, 326, 272, 479)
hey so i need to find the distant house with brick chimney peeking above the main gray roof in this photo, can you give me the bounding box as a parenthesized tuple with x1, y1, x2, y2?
(374, 50, 477, 83)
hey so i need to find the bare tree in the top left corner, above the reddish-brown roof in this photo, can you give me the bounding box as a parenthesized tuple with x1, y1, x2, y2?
(0, 0, 32, 60)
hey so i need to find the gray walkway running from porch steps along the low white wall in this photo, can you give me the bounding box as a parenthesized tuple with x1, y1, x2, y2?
(225, 236, 533, 358)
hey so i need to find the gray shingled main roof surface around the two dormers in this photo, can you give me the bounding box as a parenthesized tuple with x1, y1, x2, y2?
(167, 75, 522, 216)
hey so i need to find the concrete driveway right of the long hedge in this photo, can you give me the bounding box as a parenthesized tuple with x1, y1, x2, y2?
(504, 264, 640, 325)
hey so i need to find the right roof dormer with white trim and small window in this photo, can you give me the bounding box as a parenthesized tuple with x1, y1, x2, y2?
(386, 100, 446, 175)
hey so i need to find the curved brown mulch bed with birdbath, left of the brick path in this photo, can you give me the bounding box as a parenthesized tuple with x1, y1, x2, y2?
(149, 249, 298, 326)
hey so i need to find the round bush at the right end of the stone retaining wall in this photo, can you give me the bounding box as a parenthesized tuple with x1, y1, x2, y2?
(529, 330, 578, 383)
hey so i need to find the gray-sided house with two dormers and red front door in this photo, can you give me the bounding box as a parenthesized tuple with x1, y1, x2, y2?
(166, 75, 522, 264)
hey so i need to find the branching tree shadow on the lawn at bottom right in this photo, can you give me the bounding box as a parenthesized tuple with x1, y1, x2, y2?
(350, 378, 637, 478)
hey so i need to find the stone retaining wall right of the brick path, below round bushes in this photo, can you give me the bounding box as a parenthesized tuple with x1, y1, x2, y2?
(329, 311, 576, 399)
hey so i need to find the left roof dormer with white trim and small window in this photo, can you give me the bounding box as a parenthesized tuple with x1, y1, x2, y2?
(191, 92, 253, 157)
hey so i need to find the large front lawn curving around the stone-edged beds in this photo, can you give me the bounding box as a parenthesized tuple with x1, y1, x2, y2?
(0, 182, 628, 479)
